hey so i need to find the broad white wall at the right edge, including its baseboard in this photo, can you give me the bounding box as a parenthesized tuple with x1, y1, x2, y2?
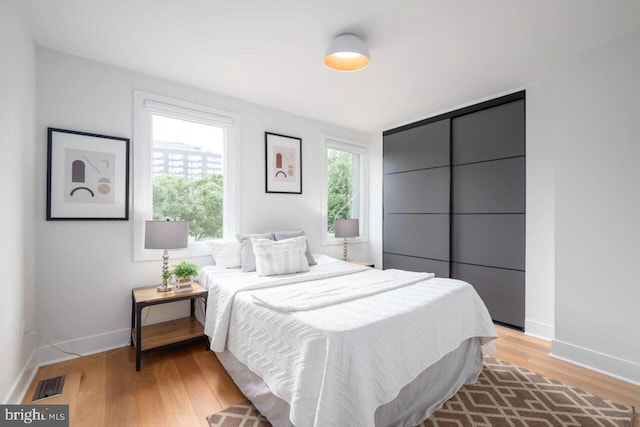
(552, 33, 640, 383)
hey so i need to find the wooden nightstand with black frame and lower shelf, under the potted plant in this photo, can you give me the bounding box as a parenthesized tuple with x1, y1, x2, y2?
(130, 283, 209, 371)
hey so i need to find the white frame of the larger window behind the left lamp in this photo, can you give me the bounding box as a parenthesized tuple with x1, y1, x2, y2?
(132, 90, 240, 262)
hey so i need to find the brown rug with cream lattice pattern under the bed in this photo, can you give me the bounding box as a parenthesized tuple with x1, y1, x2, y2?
(207, 356, 634, 427)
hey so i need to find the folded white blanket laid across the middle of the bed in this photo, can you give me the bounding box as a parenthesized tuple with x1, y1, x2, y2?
(252, 269, 435, 311)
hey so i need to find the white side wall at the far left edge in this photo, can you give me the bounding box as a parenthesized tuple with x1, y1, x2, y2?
(0, 0, 36, 403)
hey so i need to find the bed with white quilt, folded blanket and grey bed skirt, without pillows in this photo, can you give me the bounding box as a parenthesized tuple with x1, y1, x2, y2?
(200, 255, 497, 427)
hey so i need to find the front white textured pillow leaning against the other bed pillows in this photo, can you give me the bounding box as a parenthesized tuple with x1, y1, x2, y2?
(251, 236, 309, 276)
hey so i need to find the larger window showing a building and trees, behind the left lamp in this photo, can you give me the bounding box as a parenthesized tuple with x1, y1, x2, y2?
(133, 91, 238, 261)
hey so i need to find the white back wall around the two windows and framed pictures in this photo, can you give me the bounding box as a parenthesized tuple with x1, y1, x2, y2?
(36, 49, 369, 361)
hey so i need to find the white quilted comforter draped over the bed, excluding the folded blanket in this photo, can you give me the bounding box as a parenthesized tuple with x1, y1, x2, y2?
(201, 260, 497, 427)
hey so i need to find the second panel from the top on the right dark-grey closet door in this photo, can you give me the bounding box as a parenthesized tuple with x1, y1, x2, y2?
(452, 157, 525, 213)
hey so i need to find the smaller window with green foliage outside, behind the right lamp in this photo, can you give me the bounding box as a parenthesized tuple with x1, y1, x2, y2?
(322, 136, 368, 244)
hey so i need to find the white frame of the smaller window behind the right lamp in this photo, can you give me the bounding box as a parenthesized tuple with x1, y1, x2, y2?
(320, 135, 369, 245)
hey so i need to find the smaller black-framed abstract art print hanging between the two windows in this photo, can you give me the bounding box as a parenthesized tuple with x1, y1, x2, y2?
(264, 132, 302, 194)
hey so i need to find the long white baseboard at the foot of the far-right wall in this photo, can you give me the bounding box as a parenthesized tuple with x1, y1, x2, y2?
(550, 340, 640, 385)
